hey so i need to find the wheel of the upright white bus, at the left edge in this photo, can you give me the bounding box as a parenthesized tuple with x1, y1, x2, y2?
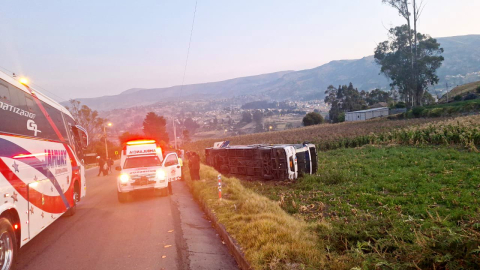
(0, 217, 17, 269)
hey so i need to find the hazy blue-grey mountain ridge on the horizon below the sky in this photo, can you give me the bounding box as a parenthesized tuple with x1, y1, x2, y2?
(66, 35, 480, 110)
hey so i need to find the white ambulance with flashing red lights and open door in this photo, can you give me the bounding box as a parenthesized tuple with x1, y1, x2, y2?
(116, 140, 182, 203)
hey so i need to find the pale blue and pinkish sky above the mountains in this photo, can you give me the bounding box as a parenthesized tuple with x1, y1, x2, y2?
(0, 0, 480, 101)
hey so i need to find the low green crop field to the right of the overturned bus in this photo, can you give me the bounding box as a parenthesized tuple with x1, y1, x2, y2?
(244, 146, 480, 269)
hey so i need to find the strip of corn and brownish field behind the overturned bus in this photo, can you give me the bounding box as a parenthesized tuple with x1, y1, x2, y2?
(185, 115, 480, 155)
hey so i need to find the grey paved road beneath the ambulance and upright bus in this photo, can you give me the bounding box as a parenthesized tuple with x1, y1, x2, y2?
(16, 166, 237, 270)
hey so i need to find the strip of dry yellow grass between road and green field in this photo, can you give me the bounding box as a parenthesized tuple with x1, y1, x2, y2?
(187, 165, 329, 269)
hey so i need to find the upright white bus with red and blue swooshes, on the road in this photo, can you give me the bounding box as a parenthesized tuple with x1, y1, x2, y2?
(0, 72, 88, 269)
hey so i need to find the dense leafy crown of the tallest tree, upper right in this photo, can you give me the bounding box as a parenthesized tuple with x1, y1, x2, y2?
(375, 25, 444, 106)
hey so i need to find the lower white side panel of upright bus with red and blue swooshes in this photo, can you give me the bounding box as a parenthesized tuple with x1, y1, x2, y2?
(0, 136, 73, 243)
